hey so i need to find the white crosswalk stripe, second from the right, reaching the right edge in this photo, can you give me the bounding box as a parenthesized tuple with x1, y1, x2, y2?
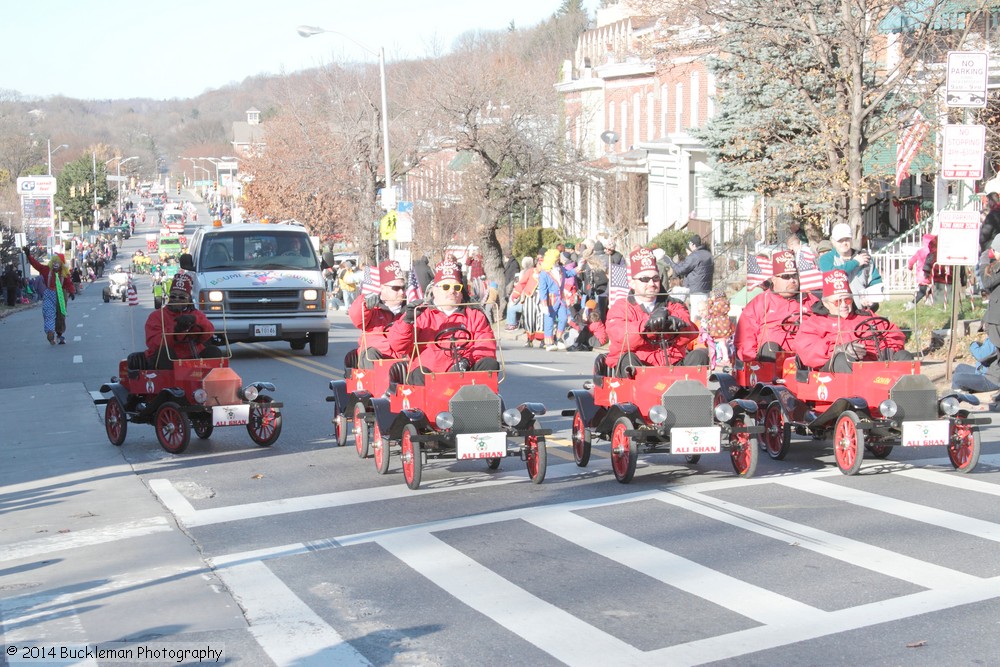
(778, 479, 1000, 542)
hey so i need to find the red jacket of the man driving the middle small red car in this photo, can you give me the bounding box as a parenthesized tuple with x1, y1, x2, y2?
(605, 294, 698, 368)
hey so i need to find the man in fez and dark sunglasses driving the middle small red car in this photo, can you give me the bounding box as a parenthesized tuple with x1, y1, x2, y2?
(605, 248, 708, 375)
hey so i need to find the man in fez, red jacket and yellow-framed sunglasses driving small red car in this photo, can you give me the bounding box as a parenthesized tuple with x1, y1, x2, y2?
(388, 261, 500, 384)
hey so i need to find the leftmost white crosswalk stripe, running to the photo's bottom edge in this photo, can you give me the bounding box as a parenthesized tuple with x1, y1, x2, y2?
(217, 562, 371, 667)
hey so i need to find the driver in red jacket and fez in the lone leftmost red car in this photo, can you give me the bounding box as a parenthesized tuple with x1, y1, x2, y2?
(146, 273, 222, 370)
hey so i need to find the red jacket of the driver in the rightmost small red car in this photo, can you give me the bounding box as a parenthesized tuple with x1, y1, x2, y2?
(792, 301, 906, 368)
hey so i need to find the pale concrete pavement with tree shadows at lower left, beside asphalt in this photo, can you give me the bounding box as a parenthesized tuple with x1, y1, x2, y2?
(0, 383, 247, 649)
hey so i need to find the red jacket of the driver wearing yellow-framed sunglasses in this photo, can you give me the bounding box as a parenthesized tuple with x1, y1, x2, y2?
(389, 306, 497, 373)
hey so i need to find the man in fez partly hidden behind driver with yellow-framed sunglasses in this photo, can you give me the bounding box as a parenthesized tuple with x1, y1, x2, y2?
(347, 259, 406, 368)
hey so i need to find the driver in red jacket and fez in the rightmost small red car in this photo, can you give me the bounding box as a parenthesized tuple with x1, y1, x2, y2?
(792, 269, 913, 373)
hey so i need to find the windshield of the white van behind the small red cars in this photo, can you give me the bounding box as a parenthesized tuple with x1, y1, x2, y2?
(198, 230, 319, 270)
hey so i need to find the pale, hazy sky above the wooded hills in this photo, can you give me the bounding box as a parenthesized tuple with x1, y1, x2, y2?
(0, 0, 598, 100)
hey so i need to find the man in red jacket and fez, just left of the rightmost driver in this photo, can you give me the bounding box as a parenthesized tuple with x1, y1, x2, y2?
(734, 250, 819, 361)
